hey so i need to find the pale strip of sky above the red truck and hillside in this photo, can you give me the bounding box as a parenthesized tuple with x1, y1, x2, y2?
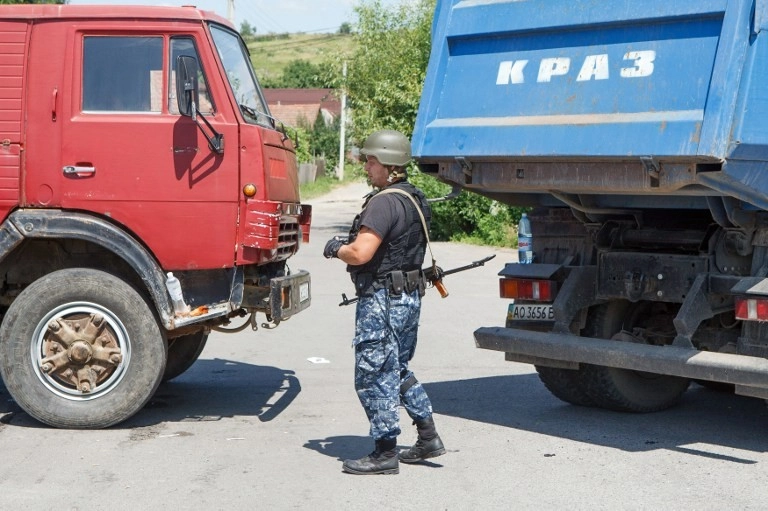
(69, 0, 409, 34)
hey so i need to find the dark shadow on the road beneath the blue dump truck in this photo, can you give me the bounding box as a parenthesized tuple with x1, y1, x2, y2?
(424, 374, 768, 463)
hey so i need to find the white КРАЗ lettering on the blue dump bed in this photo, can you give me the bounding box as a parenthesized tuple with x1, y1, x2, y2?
(496, 50, 656, 85)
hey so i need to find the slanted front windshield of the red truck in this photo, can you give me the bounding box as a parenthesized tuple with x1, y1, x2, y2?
(211, 25, 274, 127)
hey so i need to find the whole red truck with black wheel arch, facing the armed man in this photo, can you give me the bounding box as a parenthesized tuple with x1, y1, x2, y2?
(0, 5, 311, 428)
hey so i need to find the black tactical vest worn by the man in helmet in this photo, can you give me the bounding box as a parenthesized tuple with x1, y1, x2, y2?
(347, 181, 431, 296)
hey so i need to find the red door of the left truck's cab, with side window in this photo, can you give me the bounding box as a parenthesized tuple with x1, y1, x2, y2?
(49, 27, 239, 269)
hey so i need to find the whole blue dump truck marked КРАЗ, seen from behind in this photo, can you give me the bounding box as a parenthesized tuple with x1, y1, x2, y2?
(413, 0, 768, 412)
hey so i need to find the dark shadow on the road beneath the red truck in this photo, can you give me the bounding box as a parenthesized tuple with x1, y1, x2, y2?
(0, 359, 301, 429)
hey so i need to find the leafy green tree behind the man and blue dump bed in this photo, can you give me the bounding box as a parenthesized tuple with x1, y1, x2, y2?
(337, 0, 519, 245)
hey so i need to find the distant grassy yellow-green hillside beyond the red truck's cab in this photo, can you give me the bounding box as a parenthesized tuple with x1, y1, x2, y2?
(248, 34, 353, 85)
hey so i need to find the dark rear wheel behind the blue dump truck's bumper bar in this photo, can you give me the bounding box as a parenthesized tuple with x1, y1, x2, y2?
(579, 301, 690, 412)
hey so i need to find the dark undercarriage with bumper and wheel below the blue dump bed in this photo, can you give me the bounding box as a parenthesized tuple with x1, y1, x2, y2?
(442, 163, 768, 412)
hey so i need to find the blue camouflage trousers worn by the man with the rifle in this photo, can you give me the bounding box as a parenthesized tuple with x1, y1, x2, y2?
(354, 289, 432, 440)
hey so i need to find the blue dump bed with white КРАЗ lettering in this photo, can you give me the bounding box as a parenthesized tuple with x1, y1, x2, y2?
(413, 0, 768, 208)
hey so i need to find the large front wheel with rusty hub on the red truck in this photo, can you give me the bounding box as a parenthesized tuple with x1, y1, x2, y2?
(0, 268, 166, 428)
